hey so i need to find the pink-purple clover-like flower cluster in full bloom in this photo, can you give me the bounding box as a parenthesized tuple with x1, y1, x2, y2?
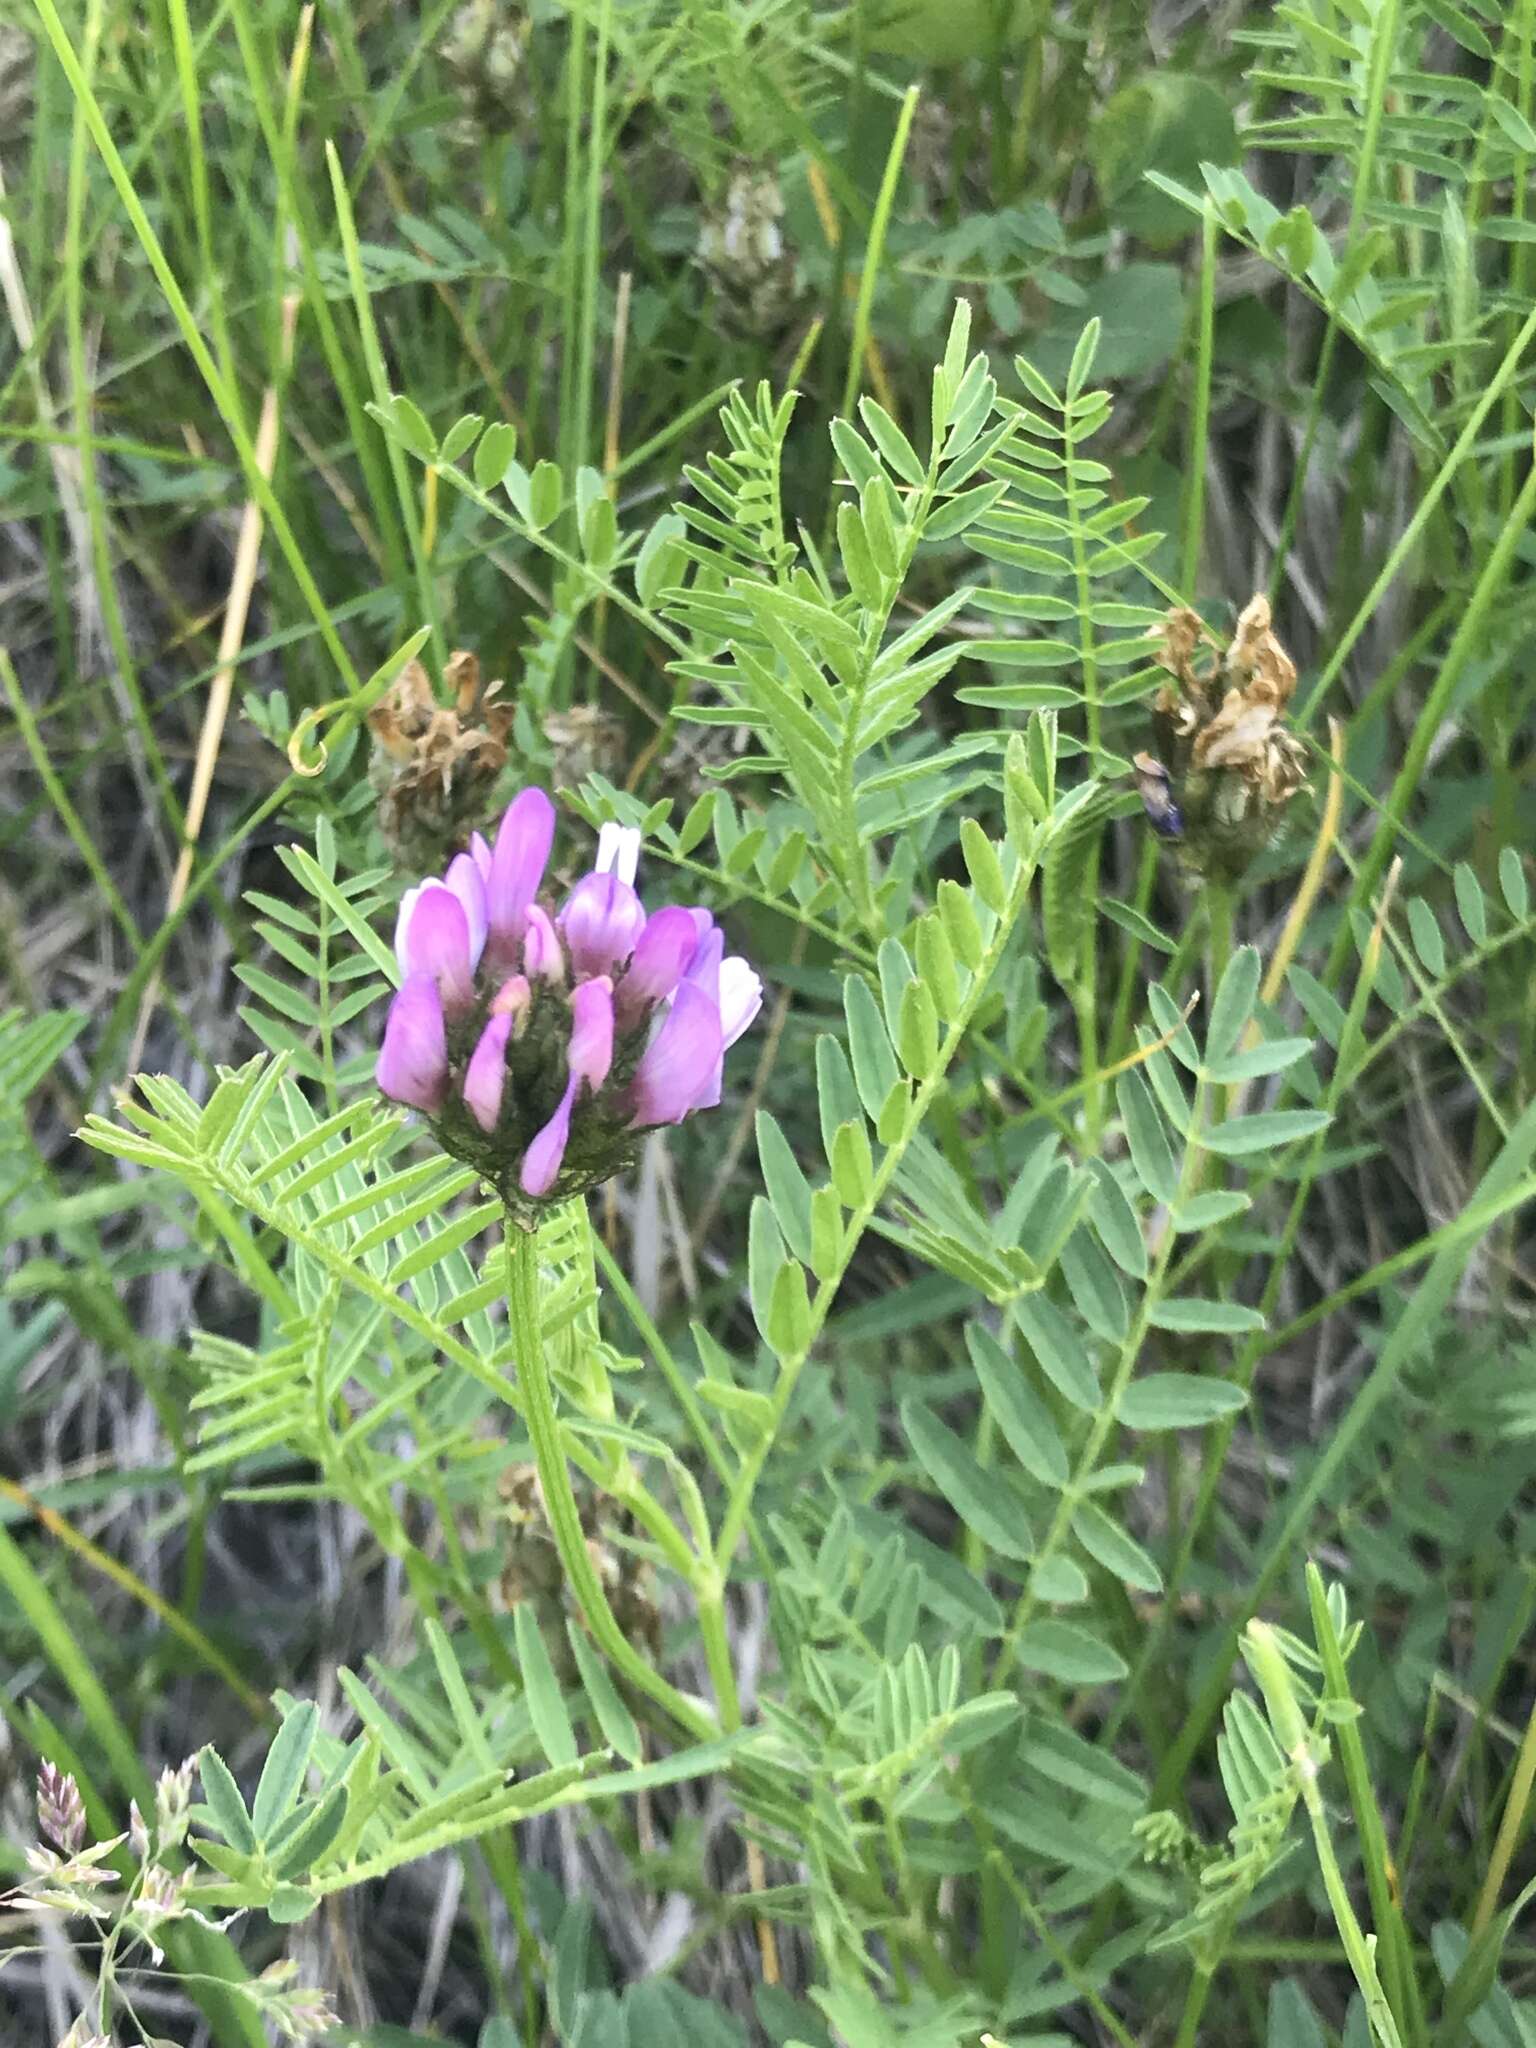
(377, 788, 762, 1208)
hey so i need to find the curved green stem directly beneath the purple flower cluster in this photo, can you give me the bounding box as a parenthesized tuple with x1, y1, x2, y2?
(504, 1217, 719, 1741)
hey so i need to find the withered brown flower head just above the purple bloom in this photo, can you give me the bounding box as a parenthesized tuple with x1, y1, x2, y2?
(369, 651, 512, 868)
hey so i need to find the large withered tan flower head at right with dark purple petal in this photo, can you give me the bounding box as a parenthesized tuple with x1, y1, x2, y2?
(1137, 596, 1307, 881)
